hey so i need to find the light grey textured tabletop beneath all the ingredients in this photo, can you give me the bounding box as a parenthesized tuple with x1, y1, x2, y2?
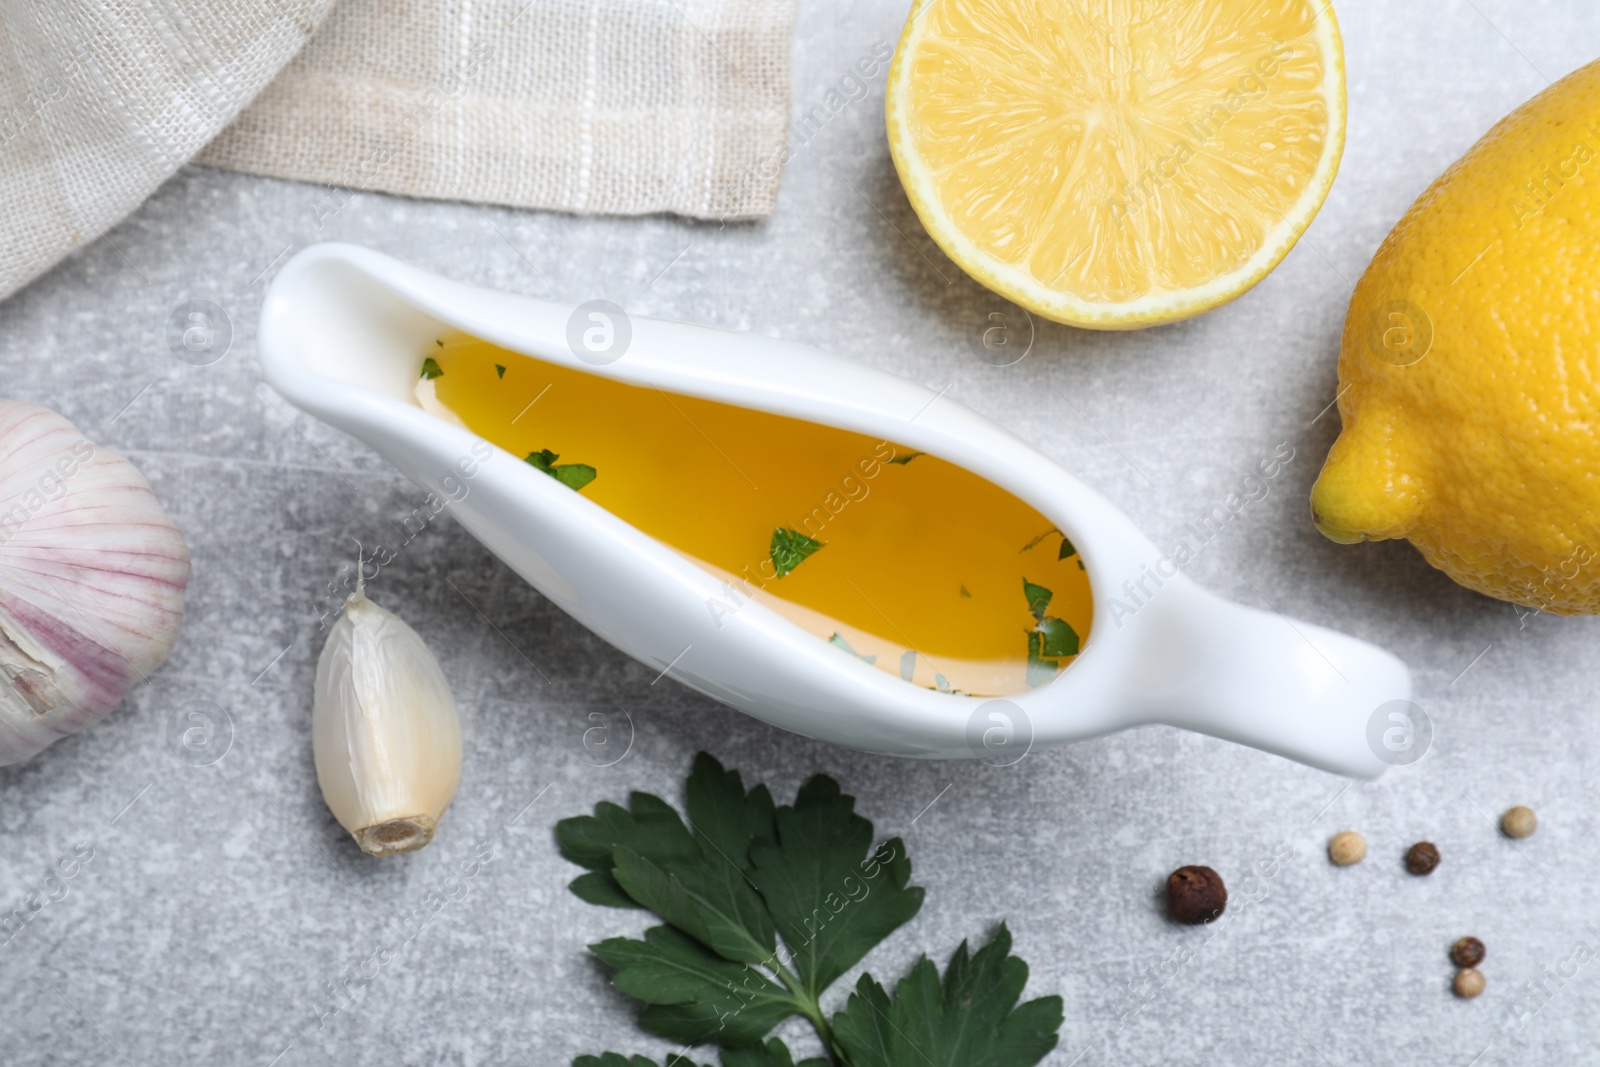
(0, 0, 1600, 1067)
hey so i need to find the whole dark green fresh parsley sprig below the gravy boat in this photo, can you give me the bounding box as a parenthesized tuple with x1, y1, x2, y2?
(555, 752, 1061, 1067)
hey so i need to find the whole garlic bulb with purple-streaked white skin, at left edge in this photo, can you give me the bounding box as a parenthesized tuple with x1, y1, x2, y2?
(0, 400, 189, 766)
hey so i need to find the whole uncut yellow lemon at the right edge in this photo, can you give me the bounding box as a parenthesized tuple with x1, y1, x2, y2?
(1310, 62, 1600, 614)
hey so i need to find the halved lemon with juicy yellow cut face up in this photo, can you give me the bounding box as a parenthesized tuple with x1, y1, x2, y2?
(886, 0, 1344, 330)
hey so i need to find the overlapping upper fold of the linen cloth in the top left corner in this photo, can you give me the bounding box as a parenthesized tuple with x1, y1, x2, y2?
(0, 0, 331, 298)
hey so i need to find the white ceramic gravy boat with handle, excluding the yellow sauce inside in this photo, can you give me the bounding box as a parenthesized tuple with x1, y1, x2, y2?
(259, 245, 1411, 777)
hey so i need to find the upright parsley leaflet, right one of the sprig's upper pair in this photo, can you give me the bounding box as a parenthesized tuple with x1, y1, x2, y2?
(750, 774, 922, 1003)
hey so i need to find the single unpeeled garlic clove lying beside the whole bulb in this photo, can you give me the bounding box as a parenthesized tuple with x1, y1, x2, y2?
(312, 589, 461, 856)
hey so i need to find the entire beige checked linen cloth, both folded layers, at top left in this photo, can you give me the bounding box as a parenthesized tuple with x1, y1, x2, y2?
(0, 0, 794, 298)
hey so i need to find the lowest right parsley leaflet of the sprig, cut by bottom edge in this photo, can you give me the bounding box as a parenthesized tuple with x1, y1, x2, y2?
(834, 923, 1062, 1067)
